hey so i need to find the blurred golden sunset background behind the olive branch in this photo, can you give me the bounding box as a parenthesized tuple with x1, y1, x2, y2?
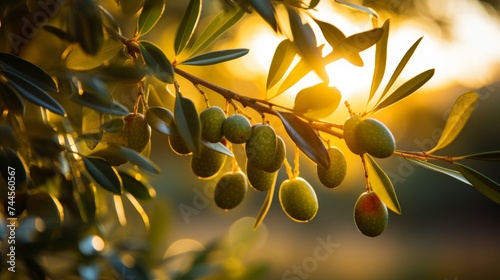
(141, 0, 500, 280)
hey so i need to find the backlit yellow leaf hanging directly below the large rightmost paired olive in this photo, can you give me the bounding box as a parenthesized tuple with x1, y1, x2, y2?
(365, 154, 401, 214)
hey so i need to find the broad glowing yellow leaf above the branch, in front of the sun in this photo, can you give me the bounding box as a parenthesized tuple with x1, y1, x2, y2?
(293, 83, 342, 119)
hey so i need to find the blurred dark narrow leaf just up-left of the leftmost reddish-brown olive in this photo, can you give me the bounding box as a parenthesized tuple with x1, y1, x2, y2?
(71, 91, 129, 116)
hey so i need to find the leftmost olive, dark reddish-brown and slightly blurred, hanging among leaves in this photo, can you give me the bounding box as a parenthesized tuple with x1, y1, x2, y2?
(123, 113, 151, 153)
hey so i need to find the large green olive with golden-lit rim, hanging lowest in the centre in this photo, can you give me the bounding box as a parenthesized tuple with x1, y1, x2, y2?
(279, 177, 318, 222)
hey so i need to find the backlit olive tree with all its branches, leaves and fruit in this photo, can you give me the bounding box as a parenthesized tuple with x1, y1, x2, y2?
(0, 0, 500, 279)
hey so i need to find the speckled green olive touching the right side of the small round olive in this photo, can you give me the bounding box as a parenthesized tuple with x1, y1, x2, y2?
(245, 124, 278, 170)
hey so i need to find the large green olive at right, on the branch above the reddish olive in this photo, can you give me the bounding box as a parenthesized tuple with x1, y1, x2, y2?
(356, 119, 396, 158)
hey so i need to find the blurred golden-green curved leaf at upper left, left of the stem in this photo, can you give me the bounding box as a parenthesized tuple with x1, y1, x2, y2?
(64, 39, 123, 71)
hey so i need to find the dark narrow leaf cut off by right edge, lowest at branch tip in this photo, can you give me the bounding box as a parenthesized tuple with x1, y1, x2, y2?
(454, 162, 500, 204)
